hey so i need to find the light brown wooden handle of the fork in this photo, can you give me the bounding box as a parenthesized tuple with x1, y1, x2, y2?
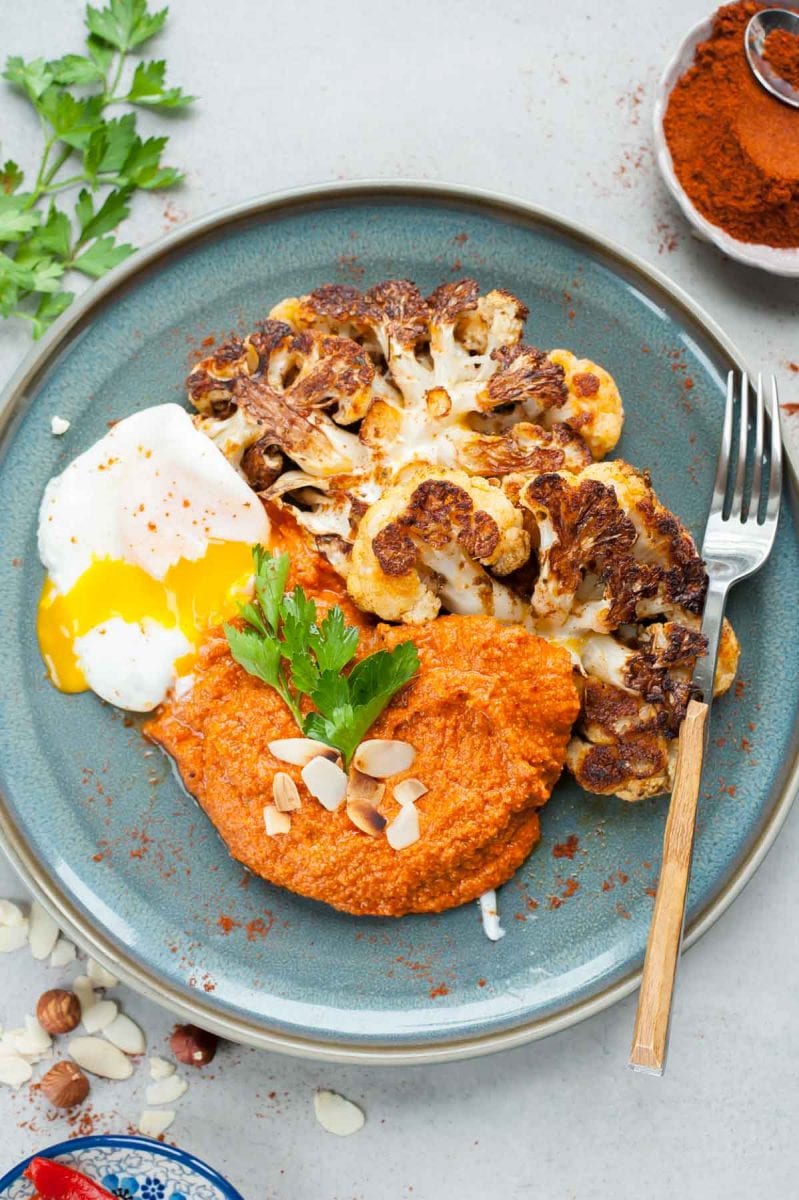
(630, 700, 708, 1075)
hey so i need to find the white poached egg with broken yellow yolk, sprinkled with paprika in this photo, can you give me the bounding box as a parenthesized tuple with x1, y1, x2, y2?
(36, 404, 269, 713)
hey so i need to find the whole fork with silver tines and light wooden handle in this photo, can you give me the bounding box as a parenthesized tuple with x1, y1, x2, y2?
(630, 371, 782, 1075)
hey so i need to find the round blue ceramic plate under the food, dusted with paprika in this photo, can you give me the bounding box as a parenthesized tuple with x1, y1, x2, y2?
(0, 185, 799, 1062)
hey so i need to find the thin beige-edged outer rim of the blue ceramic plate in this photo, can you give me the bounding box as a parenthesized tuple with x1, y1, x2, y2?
(0, 179, 799, 1066)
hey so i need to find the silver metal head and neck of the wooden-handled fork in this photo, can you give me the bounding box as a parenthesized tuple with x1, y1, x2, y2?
(693, 371, 782, 701)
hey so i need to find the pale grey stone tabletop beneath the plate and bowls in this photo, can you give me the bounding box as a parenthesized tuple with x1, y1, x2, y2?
(0, 0, 799, 1200)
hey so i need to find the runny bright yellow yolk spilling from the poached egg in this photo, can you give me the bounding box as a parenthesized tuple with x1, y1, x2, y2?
(36, 541, 252, 692)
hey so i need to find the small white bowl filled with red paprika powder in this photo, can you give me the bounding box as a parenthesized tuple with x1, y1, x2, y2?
(654, 0, 799, 277)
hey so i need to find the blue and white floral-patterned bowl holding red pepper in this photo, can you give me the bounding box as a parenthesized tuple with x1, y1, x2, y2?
(0, 1134, 242, 1200)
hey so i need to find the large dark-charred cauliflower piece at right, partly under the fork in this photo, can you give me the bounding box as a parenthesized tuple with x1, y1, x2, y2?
(504, 461, 738, 800)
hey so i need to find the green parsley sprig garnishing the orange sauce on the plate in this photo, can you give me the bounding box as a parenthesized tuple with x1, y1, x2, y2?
(224, 546, 419, 768)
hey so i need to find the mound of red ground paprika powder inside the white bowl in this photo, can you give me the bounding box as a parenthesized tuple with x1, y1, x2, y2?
(663, 0, 799, 247)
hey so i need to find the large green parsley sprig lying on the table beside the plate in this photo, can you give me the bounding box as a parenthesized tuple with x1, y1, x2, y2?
(0, 0, 194, 337)
